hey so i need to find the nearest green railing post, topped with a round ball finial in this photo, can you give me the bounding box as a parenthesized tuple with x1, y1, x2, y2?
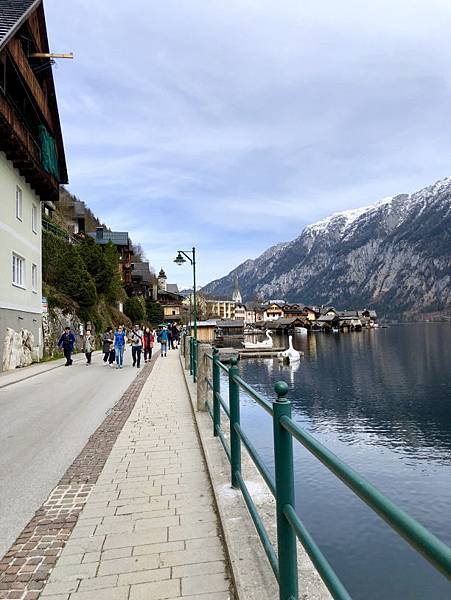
(273, 381, 298, 600)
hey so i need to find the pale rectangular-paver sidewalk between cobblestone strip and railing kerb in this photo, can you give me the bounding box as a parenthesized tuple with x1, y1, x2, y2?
(42, 351, 233, 600)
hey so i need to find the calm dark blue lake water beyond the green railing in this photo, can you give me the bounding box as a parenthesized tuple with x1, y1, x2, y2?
(225, 323, 451, 600)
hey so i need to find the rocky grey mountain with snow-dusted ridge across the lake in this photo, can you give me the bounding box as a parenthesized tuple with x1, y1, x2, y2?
(203, 177, 451, 318)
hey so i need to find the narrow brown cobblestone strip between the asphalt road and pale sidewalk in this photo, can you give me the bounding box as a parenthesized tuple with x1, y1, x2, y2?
(0, 360, 159, 600)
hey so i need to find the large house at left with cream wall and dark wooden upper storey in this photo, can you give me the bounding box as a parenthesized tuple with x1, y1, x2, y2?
(0, 0, 67, 370)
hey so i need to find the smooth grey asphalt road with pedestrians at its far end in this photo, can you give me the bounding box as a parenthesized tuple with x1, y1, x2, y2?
(0, 352, 138, 557)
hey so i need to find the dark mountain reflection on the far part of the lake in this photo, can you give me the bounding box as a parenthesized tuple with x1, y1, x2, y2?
(241, 324, 451, 460)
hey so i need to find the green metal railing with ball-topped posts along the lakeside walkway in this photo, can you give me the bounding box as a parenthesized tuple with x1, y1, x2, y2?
(195, 344, 451, 600)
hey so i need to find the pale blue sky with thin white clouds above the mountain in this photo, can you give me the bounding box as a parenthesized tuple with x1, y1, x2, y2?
(44, 0, 451, 288)
